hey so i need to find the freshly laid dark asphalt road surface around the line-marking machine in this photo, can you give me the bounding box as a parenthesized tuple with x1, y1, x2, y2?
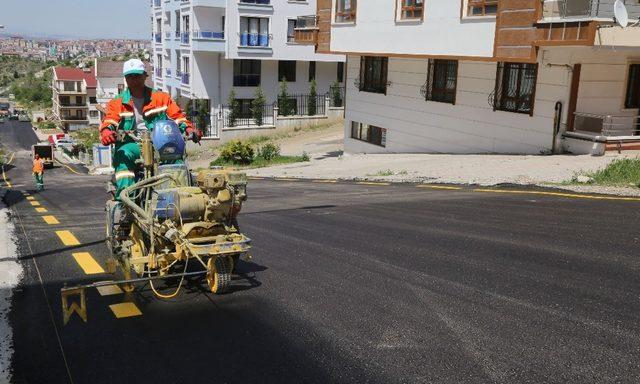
(0, 122, 640, 383)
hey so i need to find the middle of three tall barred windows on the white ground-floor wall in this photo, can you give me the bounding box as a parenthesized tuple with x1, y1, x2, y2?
(425, 59, 458, 104)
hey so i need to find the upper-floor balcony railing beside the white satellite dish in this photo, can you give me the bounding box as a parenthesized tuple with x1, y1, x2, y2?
(544, 0, 640, 19)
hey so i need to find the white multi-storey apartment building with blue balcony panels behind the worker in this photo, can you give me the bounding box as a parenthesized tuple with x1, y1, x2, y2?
(151, 0, 345, 137)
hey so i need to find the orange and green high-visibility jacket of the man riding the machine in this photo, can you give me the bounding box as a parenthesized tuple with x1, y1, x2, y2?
(100, 87, 193, 132)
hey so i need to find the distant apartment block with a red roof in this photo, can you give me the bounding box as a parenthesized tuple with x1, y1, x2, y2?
(51, 67, 100, 130)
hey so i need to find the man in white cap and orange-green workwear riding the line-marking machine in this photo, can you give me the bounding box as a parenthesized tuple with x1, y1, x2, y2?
(100, 59, 202, 200)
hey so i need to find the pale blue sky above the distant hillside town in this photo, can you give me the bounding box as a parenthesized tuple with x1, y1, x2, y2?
(0, 0, 151, 39)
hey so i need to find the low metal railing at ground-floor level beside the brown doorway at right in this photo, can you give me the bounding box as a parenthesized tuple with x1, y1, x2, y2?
(573, 112, 640, 136)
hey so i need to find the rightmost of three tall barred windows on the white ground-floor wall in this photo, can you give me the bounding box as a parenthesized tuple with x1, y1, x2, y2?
(494, 63, 538, 115)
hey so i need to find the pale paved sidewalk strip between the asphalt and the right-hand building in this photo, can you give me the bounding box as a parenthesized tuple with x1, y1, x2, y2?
(247, 152, 640, 196)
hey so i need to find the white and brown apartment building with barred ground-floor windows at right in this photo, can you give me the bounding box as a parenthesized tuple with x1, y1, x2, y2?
(295, 0, 640, 154)
